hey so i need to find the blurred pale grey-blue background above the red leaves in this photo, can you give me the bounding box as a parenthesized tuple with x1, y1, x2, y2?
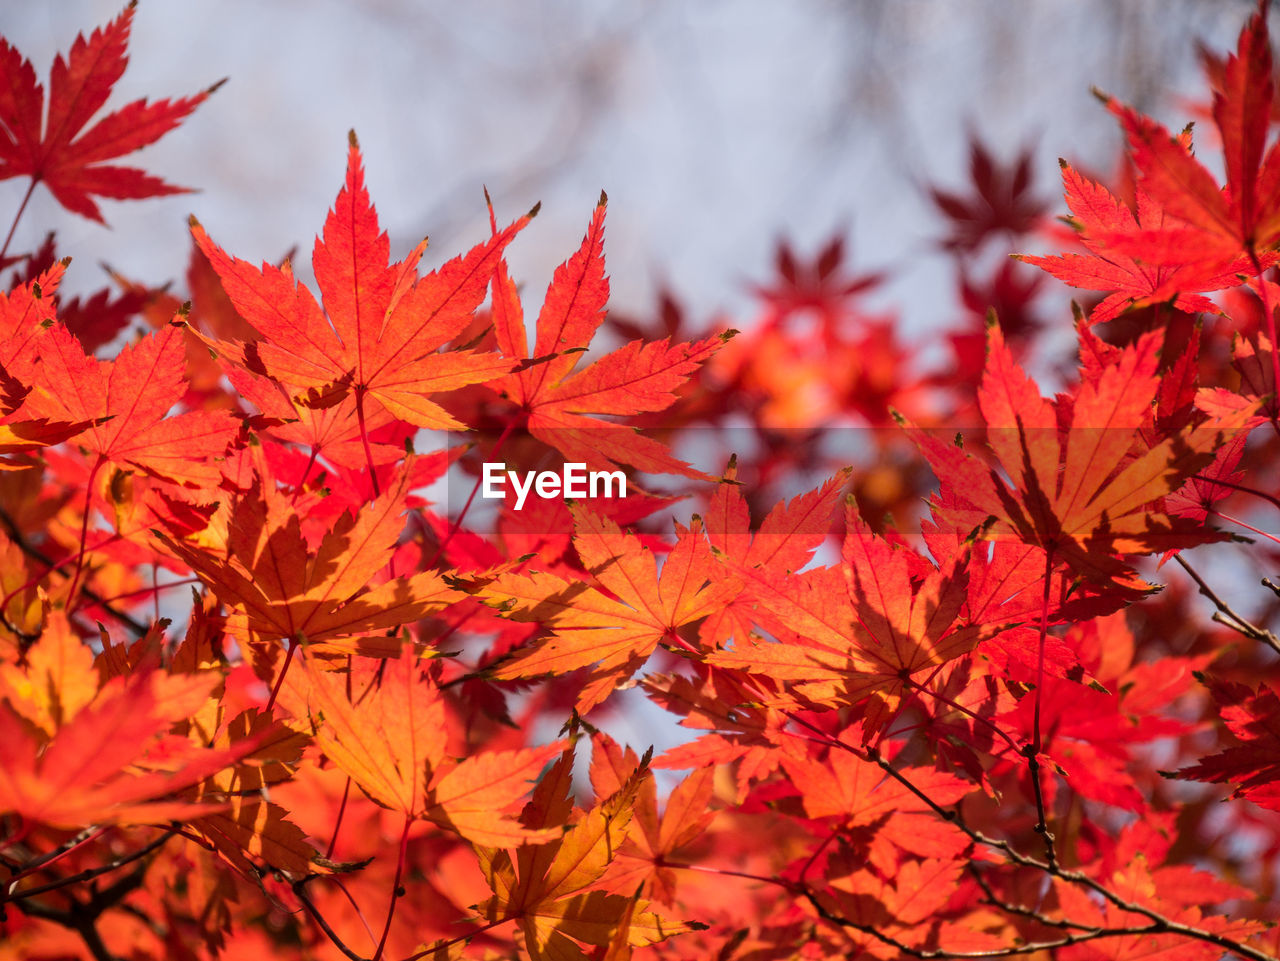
(0, 0, 1252, 337)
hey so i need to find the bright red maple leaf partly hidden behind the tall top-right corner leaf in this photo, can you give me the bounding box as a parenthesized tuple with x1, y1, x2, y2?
(1015, 160, 1249, 324)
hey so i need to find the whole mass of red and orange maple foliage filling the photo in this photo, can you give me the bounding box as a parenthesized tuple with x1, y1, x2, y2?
(0, 3, 1280, 961)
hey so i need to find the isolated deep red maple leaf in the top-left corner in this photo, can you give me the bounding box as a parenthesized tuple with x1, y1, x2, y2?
(0, 3, 220, 223)
